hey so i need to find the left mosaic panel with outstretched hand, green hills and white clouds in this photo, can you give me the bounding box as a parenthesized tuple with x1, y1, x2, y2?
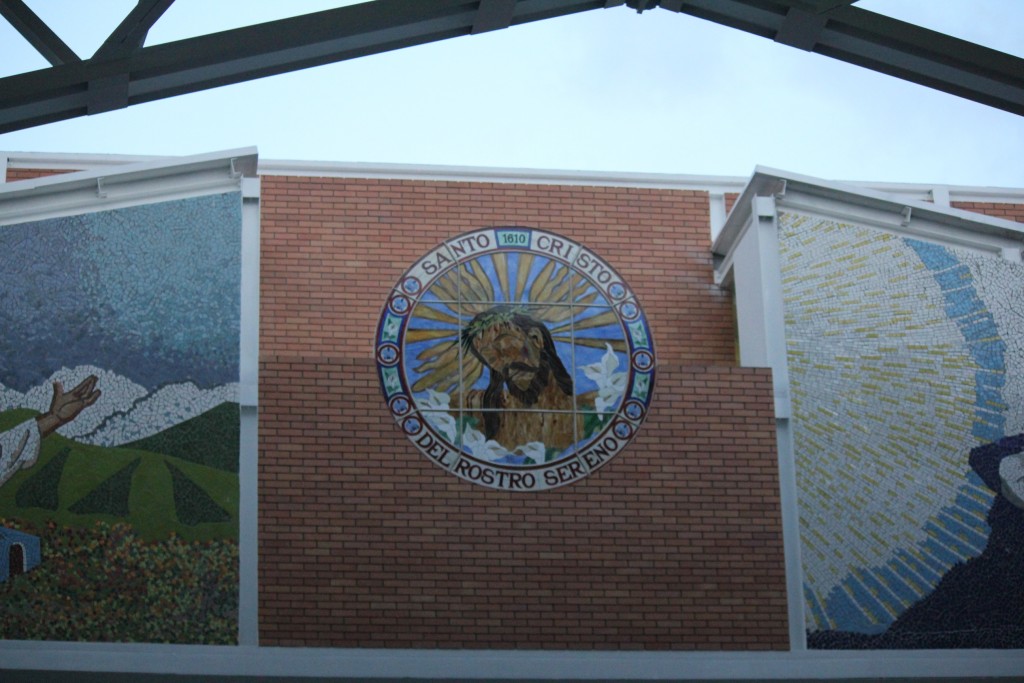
(0, 193, 242, 644)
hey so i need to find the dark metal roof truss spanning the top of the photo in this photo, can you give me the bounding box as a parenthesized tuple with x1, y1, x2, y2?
(0, 0, 1024, 133)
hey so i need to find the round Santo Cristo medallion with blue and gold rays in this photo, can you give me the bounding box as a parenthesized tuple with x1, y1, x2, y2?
(376, 227, 655, 490)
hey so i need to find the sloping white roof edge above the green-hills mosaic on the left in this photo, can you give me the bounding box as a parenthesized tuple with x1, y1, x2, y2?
(0, 147, 258, 225)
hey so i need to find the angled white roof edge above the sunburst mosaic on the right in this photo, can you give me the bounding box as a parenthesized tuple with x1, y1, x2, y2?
(712, 166, 1024, 283)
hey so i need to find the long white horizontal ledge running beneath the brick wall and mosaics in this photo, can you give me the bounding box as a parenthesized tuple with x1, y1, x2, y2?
(0, 641, 1021, 681)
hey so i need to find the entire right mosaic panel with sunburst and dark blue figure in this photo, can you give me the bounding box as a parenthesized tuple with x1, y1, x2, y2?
(779, 213, 1024, 648)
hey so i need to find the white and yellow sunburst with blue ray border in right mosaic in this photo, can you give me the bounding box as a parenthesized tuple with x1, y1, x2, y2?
(779, 214, 1022, 634)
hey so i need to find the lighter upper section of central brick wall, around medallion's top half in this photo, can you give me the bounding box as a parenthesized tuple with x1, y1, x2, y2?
(260, 177, 734, 365)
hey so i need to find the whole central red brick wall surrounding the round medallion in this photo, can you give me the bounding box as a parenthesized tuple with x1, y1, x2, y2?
(259, 177, 788, 650)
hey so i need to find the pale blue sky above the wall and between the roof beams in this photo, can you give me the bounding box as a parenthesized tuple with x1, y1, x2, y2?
(0, 0, 1024, 187)
